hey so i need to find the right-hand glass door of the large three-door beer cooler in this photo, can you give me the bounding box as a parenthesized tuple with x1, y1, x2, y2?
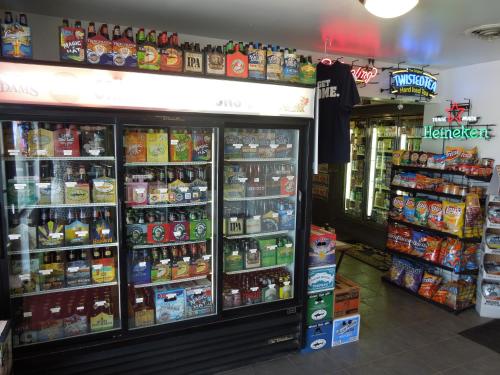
(223, 128, 299, 310)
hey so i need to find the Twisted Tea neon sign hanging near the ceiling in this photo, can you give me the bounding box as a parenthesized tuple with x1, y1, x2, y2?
(390, 68, 437, 99)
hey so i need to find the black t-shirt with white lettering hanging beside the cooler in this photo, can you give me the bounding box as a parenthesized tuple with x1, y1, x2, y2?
(316, 61, 360, 163)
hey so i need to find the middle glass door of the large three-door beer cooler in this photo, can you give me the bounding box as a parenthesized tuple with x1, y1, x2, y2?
(123, 125, 217, 329)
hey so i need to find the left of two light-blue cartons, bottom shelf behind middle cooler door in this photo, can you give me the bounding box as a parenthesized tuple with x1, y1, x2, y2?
(155, 287, 186, 324)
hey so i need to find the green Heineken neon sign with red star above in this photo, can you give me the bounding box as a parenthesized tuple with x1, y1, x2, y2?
(423, 101, 493, 140)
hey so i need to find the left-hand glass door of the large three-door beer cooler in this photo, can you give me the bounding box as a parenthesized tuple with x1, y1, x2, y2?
(0, 121, 121, 346)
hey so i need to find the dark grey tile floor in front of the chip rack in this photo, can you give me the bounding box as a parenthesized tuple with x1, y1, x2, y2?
(219, 256, 500, 375)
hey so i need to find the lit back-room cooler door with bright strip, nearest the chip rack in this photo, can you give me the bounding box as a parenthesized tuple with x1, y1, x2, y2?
(367, 118, 399, 225)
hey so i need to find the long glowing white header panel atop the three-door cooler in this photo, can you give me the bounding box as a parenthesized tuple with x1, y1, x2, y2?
(0, 62, 315, 118)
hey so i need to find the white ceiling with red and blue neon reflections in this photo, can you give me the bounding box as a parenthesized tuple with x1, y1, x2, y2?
(0, 0, 500, 67)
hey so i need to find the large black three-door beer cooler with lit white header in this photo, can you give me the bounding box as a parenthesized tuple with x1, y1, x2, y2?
(0, 62, 314, 374)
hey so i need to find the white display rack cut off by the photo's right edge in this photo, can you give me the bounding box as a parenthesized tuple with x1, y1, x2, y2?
(476, 165, 500, 319)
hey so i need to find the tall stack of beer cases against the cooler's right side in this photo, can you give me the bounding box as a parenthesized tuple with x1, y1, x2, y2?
(303, 225, 336, 353)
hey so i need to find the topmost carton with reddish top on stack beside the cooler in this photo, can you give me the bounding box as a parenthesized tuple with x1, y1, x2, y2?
(309, 225, 336, 267)
